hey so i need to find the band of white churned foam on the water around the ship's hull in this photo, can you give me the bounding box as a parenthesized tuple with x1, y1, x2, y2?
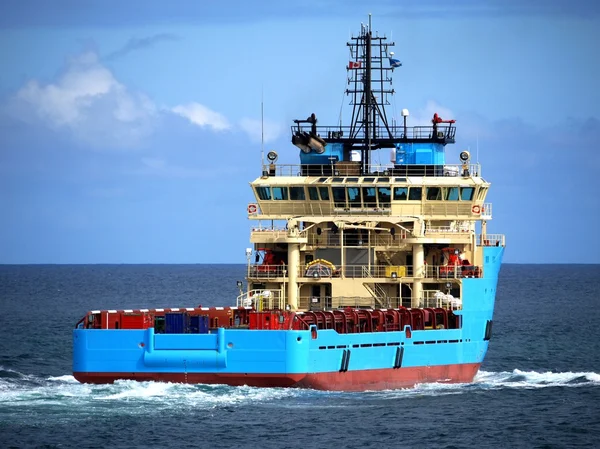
(0, 369, 600, 408)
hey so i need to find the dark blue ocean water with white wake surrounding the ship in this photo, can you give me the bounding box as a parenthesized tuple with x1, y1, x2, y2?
(0, 265, 600, 448)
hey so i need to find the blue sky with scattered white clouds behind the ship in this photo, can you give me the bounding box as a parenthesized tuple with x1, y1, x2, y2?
(0, 0, 600, 264)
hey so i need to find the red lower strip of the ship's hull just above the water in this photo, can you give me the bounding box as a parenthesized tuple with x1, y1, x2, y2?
(73, 363, 480, 391)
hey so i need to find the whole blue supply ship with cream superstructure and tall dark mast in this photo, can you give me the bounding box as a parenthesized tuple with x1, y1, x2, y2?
(73, 18, 505, 391)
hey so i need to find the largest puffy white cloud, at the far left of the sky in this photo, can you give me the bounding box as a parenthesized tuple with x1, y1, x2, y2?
(8, 52, 156, 148)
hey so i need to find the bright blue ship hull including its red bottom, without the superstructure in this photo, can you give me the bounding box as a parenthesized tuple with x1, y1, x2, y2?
(73, 247, 504, 390)
